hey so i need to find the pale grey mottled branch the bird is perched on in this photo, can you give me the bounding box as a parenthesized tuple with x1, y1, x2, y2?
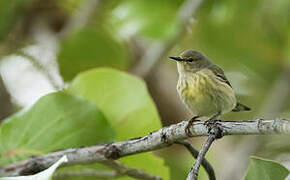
(0, 119, 290, 176)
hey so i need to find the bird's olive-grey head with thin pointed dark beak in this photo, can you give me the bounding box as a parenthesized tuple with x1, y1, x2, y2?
(169, 49, 211, 73)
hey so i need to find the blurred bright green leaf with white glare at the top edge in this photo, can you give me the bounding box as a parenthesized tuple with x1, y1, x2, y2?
(111, 0, 182, 40)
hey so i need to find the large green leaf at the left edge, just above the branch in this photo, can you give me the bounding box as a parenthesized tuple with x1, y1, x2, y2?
(0, 92, 114, 165)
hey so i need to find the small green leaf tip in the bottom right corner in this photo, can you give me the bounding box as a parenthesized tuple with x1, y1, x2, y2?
(245, 157, 289, 180)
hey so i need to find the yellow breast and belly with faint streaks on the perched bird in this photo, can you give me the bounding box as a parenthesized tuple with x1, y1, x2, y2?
(177, 71, 236, 116)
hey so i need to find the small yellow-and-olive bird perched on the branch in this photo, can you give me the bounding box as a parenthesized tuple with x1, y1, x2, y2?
(169, 50, 250, 123)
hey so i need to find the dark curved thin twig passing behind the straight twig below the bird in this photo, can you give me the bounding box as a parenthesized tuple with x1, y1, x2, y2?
(176, 140, 216, 180)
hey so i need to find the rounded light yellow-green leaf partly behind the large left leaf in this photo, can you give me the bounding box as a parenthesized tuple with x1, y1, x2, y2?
(68, 68, 161, 140)
